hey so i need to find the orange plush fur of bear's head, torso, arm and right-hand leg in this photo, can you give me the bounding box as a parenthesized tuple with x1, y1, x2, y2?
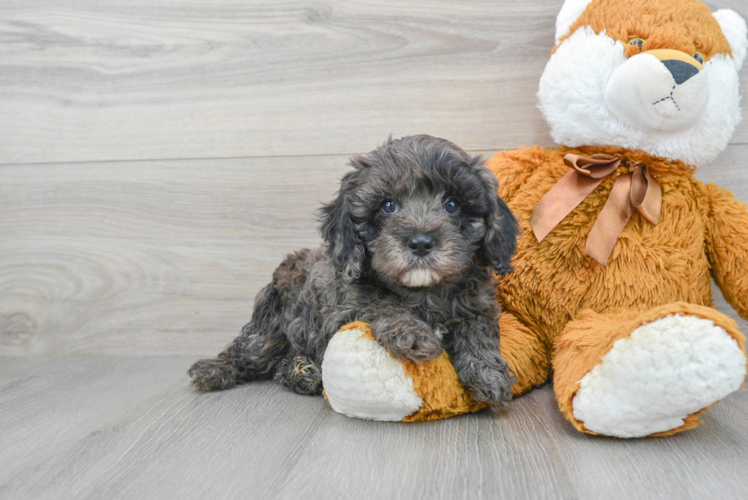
(489, 0, 748, 435)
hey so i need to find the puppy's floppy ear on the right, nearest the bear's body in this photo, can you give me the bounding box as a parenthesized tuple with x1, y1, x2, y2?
(470, 156, 520, 276)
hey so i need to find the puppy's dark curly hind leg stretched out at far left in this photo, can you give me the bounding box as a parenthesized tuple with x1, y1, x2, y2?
(187, 284, 288, 391)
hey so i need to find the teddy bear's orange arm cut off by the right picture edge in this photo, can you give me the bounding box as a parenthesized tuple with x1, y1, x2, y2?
(706, 184, 748, 319)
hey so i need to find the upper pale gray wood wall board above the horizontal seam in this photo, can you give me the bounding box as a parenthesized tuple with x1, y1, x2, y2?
(0, 0, 748, 164)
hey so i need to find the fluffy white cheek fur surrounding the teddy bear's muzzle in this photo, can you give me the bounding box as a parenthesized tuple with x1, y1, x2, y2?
(538, 27, 740, 166)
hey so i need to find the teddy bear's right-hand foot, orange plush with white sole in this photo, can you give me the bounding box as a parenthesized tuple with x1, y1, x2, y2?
(553, 302, 746, 438)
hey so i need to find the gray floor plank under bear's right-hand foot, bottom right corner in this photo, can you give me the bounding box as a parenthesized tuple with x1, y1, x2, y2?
(542, 380, 748, 500)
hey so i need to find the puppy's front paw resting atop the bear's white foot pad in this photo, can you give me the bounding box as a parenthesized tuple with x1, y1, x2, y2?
(372, 318, 442, 363)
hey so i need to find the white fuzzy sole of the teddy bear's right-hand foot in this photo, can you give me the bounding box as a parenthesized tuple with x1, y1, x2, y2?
(573, 314, 746, 438)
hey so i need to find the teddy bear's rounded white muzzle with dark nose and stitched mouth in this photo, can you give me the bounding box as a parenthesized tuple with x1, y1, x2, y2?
(604, 49, 709, 133)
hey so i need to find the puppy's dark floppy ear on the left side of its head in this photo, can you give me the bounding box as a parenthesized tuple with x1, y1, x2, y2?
(319, 171, 366, 281)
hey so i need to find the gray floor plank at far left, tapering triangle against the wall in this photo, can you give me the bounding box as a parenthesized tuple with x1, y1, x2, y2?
(0, 357, 193, 490)
